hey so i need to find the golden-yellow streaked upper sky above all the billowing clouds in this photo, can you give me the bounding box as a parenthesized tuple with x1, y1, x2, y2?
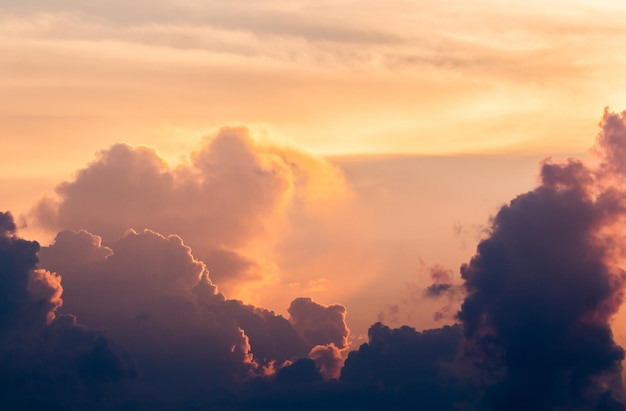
(0, 0, 626, 180)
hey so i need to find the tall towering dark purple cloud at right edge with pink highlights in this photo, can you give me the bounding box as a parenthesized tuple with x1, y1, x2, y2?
(458, 113, 626, 410)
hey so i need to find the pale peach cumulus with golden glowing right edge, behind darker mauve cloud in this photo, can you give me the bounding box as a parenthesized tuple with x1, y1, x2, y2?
(31, 127, 346, 300)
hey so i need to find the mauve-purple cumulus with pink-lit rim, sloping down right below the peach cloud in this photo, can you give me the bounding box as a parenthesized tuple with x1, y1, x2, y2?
(41, 230, 360, 395)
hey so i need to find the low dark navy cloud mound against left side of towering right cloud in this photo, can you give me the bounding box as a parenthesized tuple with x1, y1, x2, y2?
(341, 323, 469, 410)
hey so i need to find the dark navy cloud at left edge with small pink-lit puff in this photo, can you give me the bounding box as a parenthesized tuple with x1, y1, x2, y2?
(0, 213, 135, 409)
